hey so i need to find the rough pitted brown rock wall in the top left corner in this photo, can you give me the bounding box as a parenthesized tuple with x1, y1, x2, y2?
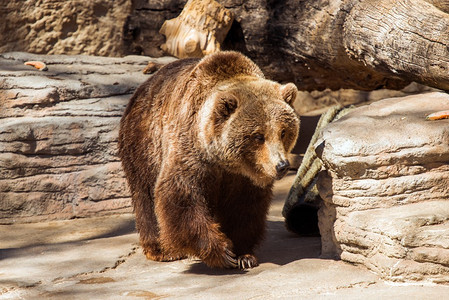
(0, 0, 132, 56)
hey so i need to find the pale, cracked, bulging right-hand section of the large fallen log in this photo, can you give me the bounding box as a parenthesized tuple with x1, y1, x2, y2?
(343, 0, 449, 90)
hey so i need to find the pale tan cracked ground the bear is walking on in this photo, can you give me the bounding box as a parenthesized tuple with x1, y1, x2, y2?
(0, 173, 449, 299)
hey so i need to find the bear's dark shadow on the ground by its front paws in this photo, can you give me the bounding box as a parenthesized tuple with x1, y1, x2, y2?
(184, 221, 321, 276)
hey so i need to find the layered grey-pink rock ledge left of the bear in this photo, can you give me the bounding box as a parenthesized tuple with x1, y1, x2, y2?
(0, 52, 174, 223)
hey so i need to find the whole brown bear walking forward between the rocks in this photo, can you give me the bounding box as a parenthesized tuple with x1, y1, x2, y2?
(119, 52, 299, 269)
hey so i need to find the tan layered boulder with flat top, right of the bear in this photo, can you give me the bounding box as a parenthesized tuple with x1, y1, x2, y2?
(316, 92, 449, 283)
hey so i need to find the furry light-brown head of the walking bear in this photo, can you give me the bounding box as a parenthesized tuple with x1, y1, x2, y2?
(199, 75, 299, 187)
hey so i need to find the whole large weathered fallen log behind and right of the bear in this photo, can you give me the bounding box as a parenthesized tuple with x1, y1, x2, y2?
(222, 0, 449, 90)
